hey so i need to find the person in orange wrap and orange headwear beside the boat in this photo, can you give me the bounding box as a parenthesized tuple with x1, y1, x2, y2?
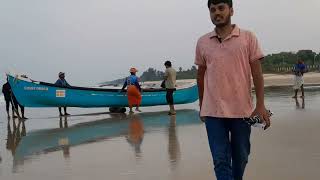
(121, 68, 141, 113)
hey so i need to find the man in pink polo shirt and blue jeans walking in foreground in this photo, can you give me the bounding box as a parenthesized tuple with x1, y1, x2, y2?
(195, 0, 270, 180)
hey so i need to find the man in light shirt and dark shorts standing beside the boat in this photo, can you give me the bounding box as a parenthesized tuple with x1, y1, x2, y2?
(164, 61, 177, 115)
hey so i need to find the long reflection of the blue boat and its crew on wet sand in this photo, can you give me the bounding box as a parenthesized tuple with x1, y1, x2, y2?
(8, 110, 200, 168)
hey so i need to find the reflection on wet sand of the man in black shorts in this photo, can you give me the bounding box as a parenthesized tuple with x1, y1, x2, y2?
(168, 116, 180, 170)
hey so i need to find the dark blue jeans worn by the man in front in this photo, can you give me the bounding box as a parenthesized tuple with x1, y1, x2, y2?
(205, 117, 251, 180)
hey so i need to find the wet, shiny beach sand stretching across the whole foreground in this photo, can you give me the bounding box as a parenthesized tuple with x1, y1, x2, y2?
(0, 87, 320, 180)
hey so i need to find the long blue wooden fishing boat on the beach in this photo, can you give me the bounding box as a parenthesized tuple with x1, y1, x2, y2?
(7, 75, 198, 108)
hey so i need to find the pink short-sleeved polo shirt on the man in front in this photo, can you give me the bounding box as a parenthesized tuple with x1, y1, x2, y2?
(195, 26, 264, 118)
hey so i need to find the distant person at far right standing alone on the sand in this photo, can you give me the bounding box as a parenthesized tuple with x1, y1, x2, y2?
(292, 59, 307, 98)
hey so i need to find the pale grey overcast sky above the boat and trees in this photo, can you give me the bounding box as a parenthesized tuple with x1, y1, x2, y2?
(0, 0, 320, 85)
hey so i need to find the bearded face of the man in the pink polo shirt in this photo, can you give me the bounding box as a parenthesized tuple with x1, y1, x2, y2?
(209, 3, 233, 27)
